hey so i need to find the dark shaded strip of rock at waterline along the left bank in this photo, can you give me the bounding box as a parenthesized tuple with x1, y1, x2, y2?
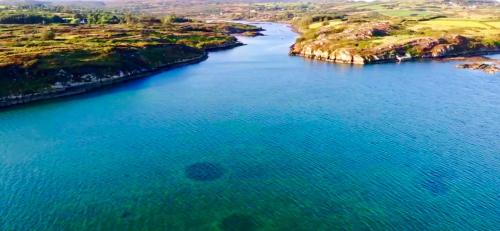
(0, 41, 245, 108)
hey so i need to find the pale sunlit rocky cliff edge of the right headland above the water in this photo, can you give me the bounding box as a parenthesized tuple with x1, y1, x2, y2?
(290, 35, 500, 64)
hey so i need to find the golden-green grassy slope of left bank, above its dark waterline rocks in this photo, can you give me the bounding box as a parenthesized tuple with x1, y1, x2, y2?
(0, 22, 264, 97)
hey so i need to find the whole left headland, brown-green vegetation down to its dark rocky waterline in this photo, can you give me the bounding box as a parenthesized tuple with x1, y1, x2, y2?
(0, 5, 262, 108)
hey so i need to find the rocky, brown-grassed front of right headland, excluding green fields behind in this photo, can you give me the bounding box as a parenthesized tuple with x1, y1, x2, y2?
(290, 17, 500, 65)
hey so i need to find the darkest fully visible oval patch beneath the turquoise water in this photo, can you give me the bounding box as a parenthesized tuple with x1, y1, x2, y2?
(185, 162, 224, 181)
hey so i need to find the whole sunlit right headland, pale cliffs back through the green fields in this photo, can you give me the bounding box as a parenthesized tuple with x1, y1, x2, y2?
(290, 1, 500, 64)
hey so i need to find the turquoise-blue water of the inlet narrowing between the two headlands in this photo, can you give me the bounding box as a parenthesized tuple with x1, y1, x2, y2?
(0, 24, 500, 231)
